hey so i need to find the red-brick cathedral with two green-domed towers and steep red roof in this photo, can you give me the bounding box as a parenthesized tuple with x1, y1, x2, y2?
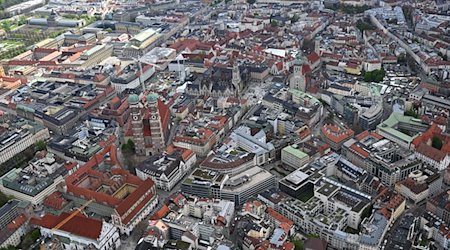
(124, 93, 170, 156)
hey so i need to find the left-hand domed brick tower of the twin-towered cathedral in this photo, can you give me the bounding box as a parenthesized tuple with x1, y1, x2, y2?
(128, 94, 145, 155)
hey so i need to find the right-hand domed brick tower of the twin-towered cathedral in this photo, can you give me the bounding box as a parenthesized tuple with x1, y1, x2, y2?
(147, 93, 165, 152)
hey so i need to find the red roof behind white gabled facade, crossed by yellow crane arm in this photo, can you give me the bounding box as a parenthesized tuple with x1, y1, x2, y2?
(30, 213, 103, 240)
